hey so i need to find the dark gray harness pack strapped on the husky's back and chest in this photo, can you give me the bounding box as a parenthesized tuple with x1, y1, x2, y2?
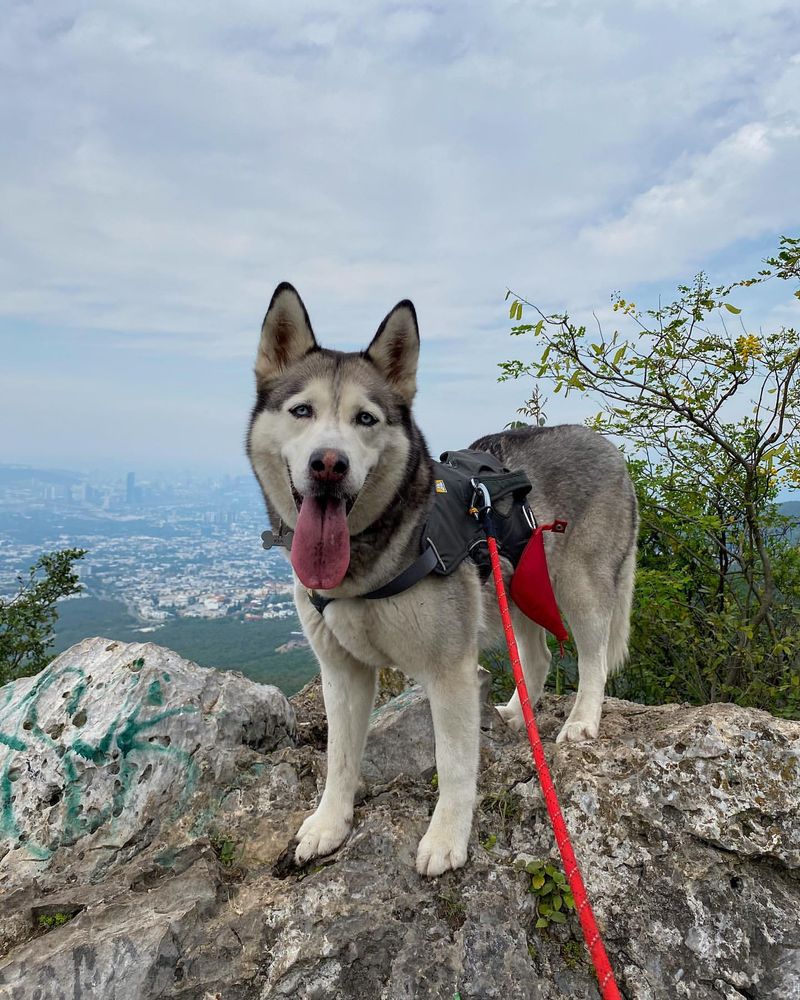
(261, 449, 536, 614)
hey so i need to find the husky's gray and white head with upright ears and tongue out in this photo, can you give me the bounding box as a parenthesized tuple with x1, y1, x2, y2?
(247, 283, 419, 590)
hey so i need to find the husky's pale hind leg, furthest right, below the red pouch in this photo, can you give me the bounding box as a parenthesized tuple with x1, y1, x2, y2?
(556, 574, 616, 743)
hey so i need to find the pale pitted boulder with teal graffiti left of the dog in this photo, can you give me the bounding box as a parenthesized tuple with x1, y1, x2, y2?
(0, 638, 294, 887)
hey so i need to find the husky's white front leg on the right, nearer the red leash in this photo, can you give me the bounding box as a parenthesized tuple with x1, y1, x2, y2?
(417, 655, 480, 877)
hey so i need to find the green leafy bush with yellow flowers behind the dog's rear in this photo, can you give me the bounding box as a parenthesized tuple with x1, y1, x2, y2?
(500, 237, 800, 718)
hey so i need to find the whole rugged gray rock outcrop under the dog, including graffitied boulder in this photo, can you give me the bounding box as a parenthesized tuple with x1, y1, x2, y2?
(0, 639, 800, 1000)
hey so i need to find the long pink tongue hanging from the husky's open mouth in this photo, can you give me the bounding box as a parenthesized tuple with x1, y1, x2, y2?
(292, 497, 350, 590)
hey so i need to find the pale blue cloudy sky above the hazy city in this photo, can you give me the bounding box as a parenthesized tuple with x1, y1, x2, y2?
(0, 0, 800, 471)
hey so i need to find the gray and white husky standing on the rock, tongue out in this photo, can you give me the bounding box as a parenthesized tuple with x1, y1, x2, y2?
(247, 284, 638, 876)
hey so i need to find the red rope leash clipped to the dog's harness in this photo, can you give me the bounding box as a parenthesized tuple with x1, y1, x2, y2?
(481, 508, 622, 1000)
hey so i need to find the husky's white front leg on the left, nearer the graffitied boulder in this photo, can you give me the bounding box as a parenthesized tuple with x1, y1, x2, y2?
(295, 644, 377, 864)
